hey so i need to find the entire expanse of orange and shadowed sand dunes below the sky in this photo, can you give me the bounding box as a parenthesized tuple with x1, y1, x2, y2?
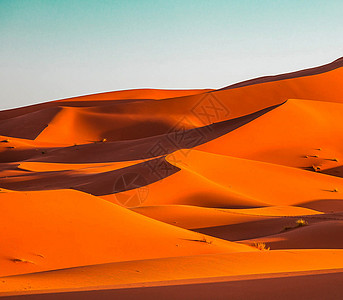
(0, 58, 343, 299)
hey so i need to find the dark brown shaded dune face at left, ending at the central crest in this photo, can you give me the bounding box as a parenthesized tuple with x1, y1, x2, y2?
(1, 157, 180, 196)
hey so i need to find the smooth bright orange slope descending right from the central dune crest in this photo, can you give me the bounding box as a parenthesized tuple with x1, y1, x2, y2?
(166, 150, 343, 205)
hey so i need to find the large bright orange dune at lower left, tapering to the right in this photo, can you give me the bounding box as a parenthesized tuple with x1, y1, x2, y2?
(0, 190, 256, 276)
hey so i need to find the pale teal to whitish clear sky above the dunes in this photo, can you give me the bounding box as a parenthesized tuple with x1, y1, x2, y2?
(0, 0, 343, 109)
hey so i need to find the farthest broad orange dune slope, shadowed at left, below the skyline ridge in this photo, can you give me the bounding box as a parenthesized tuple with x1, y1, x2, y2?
(4, 61, 343, 142)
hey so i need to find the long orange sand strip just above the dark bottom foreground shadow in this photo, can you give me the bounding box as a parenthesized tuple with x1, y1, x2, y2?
(0, 250, 343, 296)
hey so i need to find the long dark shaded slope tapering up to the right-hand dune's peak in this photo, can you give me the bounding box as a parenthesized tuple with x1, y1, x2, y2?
(28, 104, 282, 163)
